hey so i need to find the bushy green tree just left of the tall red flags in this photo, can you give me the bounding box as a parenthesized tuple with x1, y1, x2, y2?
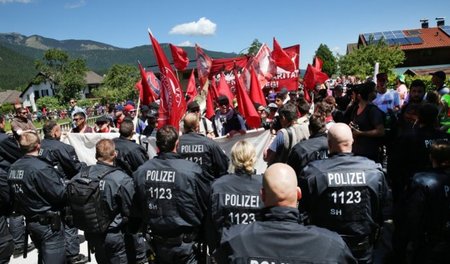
(93, 64, 141, 102)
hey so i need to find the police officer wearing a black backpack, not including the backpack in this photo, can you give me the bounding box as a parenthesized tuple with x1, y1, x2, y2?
(74, 139, 134, 264)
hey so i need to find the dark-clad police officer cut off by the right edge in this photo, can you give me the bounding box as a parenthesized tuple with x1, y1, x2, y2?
(393, 140, 450, 263)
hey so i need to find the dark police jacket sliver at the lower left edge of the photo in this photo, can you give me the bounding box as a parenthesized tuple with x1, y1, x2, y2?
(0, 168, 12, 245)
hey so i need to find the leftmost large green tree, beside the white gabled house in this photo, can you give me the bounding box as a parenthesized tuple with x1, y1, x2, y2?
(33, 49, 88, 103)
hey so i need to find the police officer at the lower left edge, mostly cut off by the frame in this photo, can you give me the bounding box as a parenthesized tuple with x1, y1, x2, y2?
(0, 168, 14, 263)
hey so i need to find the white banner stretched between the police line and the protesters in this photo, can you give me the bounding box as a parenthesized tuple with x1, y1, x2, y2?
(61, 129, 271, 173)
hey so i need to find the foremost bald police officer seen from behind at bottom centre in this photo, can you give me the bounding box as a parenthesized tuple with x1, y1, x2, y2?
(219, 163, 356, 264)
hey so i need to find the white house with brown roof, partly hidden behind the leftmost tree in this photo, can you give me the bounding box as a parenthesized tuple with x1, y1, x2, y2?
(19, 71, 103, 111)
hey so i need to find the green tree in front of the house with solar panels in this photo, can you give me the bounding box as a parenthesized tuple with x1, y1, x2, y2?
(339, 41, 405, 78)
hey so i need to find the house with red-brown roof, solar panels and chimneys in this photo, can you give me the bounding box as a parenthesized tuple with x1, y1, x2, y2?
(347, 18, 450, 75)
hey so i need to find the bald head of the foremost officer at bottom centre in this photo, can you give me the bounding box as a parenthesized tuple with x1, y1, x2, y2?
(262, 163, 301, 208)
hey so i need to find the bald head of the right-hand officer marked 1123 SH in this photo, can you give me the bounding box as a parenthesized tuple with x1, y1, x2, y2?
(328, 123, 353, 153)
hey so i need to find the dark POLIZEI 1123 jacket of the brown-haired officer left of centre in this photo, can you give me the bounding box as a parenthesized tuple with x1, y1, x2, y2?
(133, 152, 210, 237)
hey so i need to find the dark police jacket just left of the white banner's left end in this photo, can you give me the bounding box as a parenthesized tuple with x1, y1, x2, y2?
(39, 138, 84, 179)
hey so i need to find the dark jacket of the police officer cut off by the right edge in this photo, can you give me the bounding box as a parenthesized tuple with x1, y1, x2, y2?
(399, 168, 450, 253)
